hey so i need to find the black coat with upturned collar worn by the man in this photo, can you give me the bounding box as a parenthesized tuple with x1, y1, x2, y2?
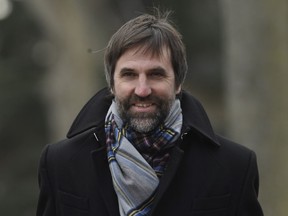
(37, 89, 263, 216)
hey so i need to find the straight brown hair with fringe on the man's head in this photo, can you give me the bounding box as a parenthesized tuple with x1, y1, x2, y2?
(104, 9, 188, 88)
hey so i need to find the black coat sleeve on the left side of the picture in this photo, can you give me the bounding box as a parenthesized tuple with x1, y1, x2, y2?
(36, 145, 57, 216)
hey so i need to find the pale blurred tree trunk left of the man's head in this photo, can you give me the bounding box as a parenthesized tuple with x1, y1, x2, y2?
(27, 0, 110, 141)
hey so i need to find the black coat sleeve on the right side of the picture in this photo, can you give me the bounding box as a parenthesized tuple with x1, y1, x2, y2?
(237, 152, 263, 216)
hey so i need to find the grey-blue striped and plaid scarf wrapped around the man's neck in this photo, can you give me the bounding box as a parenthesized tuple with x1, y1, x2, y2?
(105, 100, 182, 216)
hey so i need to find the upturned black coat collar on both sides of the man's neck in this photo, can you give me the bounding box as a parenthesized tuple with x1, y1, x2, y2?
(67, 88, 219, 145)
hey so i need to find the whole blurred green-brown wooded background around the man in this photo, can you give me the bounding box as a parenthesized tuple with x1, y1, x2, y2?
(0, 0, 288, 216)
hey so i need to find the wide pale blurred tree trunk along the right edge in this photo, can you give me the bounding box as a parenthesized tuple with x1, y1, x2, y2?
(222, 0, 288, 216)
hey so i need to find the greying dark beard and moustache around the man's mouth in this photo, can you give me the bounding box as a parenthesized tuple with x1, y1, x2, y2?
(115, 94, 175, 133)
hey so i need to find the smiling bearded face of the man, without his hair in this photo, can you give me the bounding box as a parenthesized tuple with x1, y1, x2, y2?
(113, 47, 181, 133)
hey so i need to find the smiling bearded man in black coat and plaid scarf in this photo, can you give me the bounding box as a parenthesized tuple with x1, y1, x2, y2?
(37, 9, 263, 216)
